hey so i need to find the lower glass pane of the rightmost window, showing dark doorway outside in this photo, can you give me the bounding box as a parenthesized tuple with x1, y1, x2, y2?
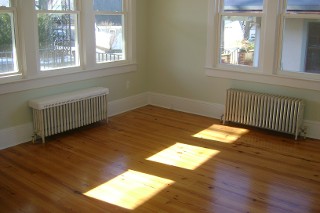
(281, 18, 320, 74)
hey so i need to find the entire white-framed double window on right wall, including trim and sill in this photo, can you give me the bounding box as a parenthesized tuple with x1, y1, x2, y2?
(205, 0, 320, 90)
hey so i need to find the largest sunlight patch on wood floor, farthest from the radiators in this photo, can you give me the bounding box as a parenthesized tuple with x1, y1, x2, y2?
(84, 170, 174, 210)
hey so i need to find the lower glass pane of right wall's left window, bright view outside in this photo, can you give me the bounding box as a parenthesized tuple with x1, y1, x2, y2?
(220, 16, 261, 67)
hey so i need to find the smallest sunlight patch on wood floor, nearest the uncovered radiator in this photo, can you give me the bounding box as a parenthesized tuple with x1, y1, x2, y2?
(193, 124, 249, 143)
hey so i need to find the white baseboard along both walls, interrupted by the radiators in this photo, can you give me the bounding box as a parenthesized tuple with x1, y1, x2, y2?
(0, 92, 320, 150)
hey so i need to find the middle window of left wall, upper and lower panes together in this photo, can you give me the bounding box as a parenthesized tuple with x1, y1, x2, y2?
(35, 0, 80, 71)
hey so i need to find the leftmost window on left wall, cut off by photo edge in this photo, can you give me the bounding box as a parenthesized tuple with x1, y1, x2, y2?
(0, 0, 19, 78)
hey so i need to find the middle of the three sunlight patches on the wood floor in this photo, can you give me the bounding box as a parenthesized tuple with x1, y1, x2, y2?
(147, 143, 219, 170)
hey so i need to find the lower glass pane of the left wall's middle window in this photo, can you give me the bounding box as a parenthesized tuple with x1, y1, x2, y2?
(38, 13, 78, 70)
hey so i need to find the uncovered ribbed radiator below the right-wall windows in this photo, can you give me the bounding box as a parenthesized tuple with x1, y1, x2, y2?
(223, 89, 304, 140)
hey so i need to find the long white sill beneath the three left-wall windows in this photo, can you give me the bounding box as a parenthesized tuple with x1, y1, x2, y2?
(0, 64, 137, 95)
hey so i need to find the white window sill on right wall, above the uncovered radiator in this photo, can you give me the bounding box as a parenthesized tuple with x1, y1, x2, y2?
(205, 67, 320, 91)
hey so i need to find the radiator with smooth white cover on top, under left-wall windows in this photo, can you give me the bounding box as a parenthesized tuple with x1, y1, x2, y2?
(29, 87, 109, 143)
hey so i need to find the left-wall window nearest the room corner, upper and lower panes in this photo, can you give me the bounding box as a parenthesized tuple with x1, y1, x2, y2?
(93, 0, 126, 63)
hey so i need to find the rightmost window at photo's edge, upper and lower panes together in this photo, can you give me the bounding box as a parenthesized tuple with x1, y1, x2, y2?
(280, 0, 320, 74)
